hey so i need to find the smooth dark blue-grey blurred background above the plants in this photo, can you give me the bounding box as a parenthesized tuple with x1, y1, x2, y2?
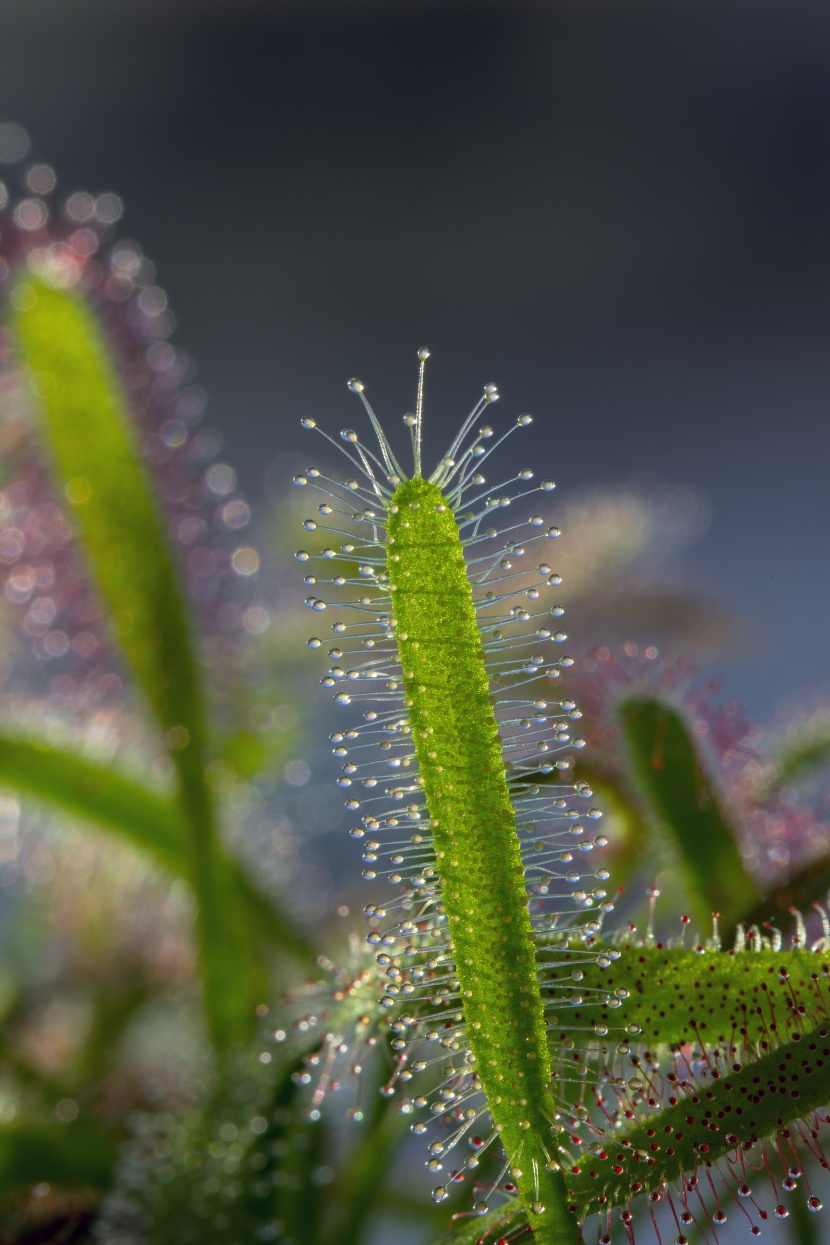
(0, 0, 830, 717)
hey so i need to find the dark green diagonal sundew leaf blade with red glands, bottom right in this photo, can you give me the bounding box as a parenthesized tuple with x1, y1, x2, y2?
(565, 1026, 830, 1214)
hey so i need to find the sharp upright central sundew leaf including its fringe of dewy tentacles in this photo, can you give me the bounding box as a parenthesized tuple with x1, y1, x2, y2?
(297, 350, 604, 1241)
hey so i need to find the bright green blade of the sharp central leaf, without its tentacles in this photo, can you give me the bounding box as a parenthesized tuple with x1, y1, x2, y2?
(387, 476, 577, 1245)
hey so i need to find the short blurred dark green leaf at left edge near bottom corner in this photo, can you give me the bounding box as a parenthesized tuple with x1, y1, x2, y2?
(0, 1118, 116, 1193)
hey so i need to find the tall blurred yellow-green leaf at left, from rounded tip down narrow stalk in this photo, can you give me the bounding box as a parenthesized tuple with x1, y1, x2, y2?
(11, 281, 254, 1050)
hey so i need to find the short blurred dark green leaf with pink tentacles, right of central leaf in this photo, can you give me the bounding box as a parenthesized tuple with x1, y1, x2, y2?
(620, 698, 758, 929)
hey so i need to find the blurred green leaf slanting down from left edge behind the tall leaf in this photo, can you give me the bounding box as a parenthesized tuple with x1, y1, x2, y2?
(0, 735, 314, 961)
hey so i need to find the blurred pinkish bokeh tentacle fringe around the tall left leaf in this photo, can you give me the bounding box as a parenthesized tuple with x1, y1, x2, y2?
(0, 135, 263, 702)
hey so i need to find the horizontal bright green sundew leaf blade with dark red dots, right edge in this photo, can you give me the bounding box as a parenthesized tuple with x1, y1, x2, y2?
(545, 946, 830, 1047)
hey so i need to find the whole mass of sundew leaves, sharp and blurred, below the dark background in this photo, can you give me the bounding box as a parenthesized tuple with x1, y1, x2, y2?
(0, 128, 830, 1245)
